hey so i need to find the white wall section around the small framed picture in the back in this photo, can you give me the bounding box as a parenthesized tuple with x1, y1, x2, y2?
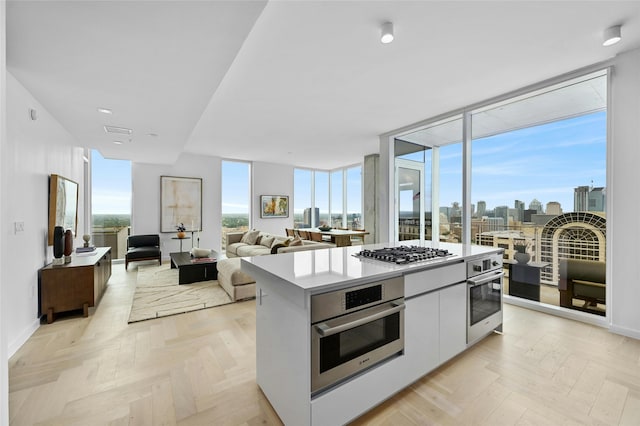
(251, 161, 293, 235)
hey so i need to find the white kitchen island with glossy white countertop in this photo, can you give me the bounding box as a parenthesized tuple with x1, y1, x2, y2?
(242, 241, 501, 425)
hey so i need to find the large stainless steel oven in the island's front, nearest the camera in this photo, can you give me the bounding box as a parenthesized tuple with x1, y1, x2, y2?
(311, 277, 404, 394)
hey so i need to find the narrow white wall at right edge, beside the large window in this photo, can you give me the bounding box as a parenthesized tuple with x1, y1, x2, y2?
(607, 49, 640, 339)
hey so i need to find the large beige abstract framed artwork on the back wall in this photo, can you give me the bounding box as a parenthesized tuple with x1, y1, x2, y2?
(160, 176, 202, 232)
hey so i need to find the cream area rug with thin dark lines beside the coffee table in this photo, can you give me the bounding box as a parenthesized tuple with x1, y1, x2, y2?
(129, 264, 233, 323)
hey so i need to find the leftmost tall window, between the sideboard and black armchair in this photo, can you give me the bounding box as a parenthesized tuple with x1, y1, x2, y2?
(90, 150, 131, 259)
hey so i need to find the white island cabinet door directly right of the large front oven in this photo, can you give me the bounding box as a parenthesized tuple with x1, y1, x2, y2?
(404, 292, 440, 380)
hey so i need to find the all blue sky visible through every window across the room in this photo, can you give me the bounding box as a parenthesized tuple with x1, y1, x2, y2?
(92, 112, 606, 214)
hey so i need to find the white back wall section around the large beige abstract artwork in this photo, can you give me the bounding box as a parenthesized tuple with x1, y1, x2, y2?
(131, 154, 222, 259)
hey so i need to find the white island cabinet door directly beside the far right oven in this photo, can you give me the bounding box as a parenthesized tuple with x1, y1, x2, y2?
(439, 283, 467, 363)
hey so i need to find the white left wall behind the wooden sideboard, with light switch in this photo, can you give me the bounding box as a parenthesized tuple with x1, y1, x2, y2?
(2, 72, 84, 356)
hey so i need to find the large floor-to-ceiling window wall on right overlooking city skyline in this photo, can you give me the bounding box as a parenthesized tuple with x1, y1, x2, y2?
(395, 70, 609, 315)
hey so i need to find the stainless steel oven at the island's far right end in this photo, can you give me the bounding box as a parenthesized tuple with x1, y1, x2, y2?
(467, 254, 504, 344)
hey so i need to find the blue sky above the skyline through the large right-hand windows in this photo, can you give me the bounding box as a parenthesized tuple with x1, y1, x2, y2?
(440, 112, 606, 212)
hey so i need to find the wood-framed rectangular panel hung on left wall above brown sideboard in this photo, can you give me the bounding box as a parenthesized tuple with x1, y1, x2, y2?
(48, 175, 78, 246)
